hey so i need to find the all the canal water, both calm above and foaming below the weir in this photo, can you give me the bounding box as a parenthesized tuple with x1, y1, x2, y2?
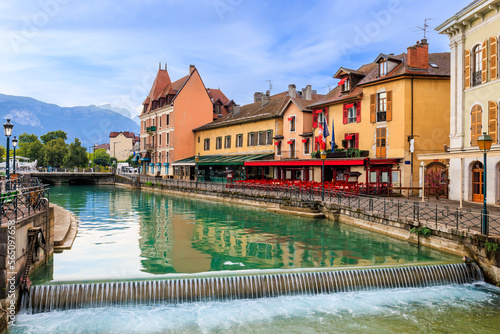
(9, 186, 500, 334)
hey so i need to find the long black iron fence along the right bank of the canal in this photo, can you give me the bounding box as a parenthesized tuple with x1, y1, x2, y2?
(140, 175, 500, 235)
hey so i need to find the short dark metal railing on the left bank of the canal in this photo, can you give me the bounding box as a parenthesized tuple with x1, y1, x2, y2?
(0, 185, 49, 224)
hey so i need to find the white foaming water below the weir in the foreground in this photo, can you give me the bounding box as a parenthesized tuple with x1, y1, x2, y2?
(9, 284, 500, 334)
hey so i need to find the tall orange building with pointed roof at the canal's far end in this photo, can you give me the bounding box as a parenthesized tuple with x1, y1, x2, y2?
(139, 65, 234, 178)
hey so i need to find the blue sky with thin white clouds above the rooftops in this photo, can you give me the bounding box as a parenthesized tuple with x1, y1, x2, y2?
(0, 0, 471, 117)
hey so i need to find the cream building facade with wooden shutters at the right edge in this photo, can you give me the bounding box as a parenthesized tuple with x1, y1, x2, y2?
(434, 0, 500, 205)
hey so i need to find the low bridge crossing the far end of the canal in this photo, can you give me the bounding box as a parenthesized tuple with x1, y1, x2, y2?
(31, 172, 115, 185)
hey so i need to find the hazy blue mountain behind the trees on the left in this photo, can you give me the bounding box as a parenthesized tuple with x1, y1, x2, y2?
(0, 94, 139, 148)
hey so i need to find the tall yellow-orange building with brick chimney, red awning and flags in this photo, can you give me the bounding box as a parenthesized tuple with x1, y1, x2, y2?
(310, 40, 450, 187)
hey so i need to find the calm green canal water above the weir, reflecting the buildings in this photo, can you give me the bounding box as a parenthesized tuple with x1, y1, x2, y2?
(31, 186, 458, 280)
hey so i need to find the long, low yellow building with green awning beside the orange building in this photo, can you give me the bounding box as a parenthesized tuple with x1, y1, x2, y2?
(178, 85, 322, 181)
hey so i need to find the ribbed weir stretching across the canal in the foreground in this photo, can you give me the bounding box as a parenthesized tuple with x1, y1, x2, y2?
(21, 263, 483, 314)
